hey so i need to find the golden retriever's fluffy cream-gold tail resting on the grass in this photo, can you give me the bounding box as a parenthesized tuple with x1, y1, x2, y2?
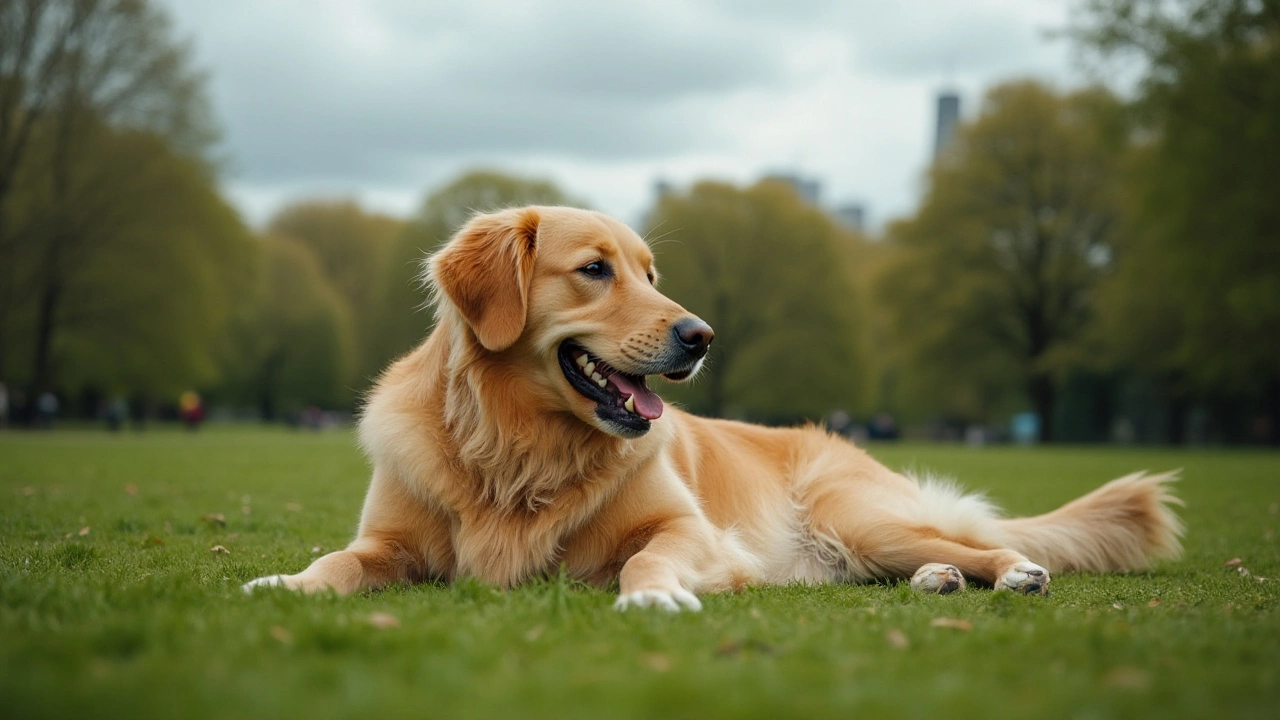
(996, 471, 1183, 573)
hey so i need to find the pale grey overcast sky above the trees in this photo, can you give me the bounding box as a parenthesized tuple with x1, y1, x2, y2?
(161, 0, 1083, 225)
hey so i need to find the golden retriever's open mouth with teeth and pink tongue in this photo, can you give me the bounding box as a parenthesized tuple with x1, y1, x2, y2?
(559, 341, 663, 434)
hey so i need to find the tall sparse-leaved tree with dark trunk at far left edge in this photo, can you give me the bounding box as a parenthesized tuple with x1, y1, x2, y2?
(0, 0, 212, 389)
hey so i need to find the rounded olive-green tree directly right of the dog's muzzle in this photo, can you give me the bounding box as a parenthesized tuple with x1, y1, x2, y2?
(646, 181, 864, 421)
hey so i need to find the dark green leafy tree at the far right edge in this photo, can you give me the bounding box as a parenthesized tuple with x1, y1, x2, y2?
(1075, 0, 1280, 443)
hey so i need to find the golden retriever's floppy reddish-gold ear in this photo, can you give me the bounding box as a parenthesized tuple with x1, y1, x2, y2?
(429, 208, 541, 352)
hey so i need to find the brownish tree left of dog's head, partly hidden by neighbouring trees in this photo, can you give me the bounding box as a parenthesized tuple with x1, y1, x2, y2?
(268, 200, 403, 389)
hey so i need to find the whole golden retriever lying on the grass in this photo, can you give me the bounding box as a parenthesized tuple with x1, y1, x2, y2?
(244, 206, 1183, 611)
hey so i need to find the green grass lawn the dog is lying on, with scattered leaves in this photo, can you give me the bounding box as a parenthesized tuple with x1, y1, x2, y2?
(0, 428, 1280, 720)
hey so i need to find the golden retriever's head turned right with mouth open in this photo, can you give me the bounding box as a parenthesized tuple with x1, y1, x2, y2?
(428, 208, 714, 437)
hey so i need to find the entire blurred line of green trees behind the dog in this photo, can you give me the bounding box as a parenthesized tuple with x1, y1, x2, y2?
(0, 0, 1280, 443)
